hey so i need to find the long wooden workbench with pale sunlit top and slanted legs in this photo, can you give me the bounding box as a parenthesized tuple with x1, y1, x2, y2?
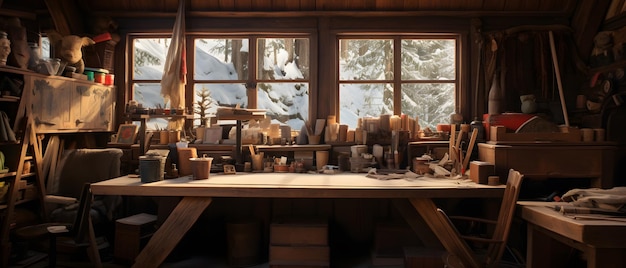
(91, 173, 504, 267)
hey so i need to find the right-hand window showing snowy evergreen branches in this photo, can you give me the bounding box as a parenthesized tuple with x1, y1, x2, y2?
(339, 36, 458, 129)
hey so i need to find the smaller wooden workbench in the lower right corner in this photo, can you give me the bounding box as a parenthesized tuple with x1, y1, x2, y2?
(518, 201, 626, 268)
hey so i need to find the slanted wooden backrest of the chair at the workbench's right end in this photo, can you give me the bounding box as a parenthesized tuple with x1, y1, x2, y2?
(486, 169, 524, 265)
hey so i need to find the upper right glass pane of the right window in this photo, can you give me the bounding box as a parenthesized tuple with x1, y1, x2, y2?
(401, 39, 456, 80)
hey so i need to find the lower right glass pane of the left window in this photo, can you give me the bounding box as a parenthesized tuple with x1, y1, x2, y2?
(257, 83, 309, 130)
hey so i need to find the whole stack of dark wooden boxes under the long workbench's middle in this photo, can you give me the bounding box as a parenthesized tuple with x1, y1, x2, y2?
(269, 220, 330, 267)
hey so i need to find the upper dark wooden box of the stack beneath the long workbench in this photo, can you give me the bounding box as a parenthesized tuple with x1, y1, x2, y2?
(270, 220, 328, 246)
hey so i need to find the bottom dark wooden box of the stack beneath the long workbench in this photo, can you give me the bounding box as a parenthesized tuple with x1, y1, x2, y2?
(269, 245, 330, 267)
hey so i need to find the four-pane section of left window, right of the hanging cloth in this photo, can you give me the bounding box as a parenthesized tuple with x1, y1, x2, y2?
(194, 36, 310, 129)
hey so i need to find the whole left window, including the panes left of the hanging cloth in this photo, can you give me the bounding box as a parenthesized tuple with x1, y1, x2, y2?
(131, 36, 310, 129)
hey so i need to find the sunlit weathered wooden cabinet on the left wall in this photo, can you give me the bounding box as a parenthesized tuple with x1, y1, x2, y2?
(25, 74, 115, 133)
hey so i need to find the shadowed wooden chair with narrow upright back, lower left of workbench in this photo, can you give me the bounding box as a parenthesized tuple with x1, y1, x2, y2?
(15, 183, 102, 267)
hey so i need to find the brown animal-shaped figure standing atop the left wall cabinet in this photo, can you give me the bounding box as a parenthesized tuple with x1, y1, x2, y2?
(48, 32, 96, 74)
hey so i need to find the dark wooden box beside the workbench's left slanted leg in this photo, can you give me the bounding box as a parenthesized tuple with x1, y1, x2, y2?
(113, 213, 157, 263)
